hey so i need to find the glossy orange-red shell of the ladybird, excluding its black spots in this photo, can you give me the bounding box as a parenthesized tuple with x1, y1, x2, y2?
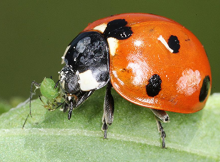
(84, 13, 212, 113)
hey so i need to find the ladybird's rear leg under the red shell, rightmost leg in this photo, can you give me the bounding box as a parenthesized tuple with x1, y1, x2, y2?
(151, 109, 170, 148)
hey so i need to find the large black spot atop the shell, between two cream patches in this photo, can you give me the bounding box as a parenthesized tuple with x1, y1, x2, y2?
(104, 19, 133, 40)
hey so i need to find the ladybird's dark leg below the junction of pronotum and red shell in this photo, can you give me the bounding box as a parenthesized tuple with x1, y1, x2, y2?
(102, 82, 114, 138)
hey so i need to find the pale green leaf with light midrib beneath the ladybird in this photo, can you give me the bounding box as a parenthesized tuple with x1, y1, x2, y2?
(0, 89, 220, 162)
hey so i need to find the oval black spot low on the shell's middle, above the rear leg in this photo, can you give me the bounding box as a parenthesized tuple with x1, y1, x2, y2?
(146, 74, 162, 97)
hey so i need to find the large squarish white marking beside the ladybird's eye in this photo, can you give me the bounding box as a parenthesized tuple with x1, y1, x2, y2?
(79, 70, 99, 91)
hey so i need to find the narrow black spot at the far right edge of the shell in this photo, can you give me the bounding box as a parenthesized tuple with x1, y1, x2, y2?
(199, 75, 210, 102)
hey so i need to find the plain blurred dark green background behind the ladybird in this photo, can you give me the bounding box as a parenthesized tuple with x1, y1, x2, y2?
(0, 0, 220, 99)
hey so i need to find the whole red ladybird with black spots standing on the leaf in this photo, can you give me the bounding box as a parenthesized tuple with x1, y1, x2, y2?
(59, 13, 212, 148)
